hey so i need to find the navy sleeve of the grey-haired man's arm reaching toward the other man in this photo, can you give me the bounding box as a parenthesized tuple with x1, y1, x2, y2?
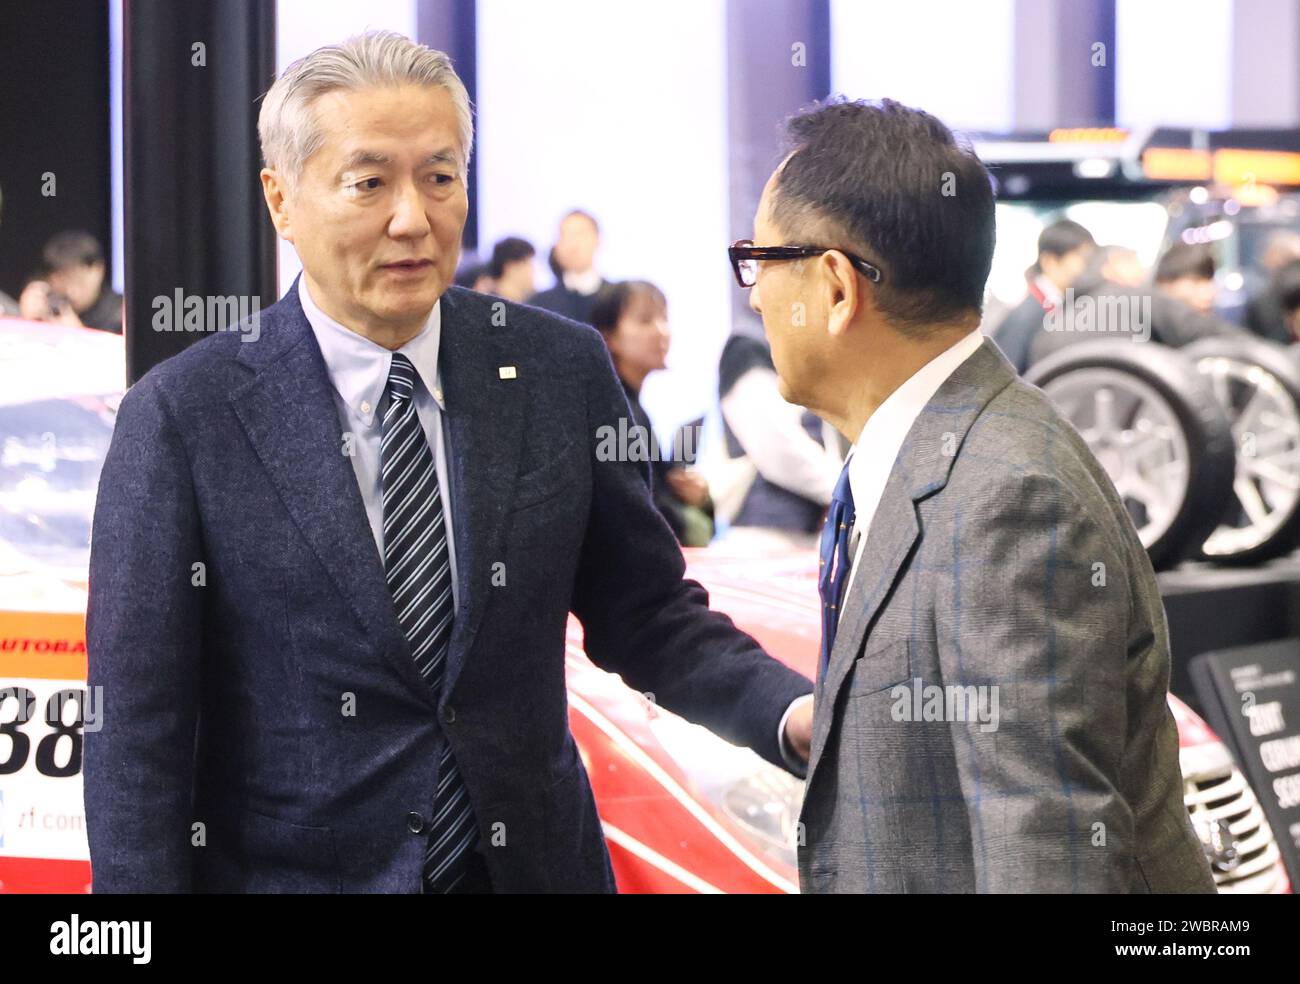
(573, 331, 813, 768)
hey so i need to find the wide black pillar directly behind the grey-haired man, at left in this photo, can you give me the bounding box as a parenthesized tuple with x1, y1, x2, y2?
(122, 0, 277, 383)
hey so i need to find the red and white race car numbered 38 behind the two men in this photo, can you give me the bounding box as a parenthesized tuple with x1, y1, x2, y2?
(0, 320, 1290, 892)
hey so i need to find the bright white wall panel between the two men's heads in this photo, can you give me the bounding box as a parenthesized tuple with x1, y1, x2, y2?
(477, 0, 732, 433)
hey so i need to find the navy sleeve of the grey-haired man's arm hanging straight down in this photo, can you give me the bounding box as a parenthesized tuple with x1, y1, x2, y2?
(85, 376, 204, 892)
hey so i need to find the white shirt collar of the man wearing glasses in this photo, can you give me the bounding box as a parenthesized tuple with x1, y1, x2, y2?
(849, 329, 984, 506)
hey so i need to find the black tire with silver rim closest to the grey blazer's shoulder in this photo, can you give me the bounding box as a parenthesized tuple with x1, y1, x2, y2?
(1024, 339, 1236, 569)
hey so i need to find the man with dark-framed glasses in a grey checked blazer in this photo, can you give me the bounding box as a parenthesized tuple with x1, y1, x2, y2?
(731, 100, 1214, 892)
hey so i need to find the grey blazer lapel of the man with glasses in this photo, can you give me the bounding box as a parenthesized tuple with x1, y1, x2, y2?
(805, 339, 1015, 785)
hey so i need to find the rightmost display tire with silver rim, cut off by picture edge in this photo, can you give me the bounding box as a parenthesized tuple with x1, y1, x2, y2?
(1182, 335, 1300, 565)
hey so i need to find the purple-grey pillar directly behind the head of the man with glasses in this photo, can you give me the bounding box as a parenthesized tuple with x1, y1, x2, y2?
(724, 0, 831, 325)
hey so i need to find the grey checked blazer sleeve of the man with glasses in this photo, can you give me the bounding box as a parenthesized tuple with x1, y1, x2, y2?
(937, 474, 1138, 893)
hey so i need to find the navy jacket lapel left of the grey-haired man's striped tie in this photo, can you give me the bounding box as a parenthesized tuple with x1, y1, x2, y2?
(230, 286, 429, 695)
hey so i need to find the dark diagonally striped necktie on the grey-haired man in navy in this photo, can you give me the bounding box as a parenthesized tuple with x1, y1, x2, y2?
(380, 352, 477, 893)
